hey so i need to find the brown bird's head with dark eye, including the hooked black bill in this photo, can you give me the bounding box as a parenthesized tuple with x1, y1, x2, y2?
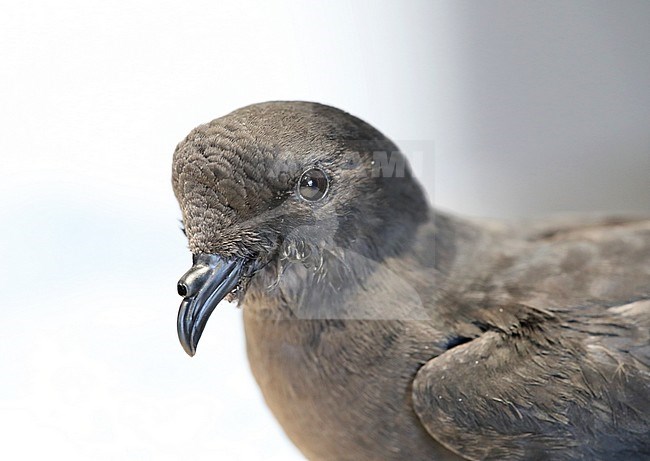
(172, 102, 427, 355)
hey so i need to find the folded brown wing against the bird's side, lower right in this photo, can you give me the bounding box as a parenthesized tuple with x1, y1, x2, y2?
(412, 300, 650, 460)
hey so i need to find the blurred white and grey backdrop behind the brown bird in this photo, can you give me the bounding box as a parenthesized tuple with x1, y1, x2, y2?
(0, 0, 650, 461)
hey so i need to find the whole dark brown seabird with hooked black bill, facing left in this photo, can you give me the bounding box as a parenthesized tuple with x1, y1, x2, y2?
(172, 101, 650, 461)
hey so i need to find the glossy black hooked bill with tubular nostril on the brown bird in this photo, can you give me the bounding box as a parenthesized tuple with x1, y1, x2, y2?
(178, 253, 244, 356)
